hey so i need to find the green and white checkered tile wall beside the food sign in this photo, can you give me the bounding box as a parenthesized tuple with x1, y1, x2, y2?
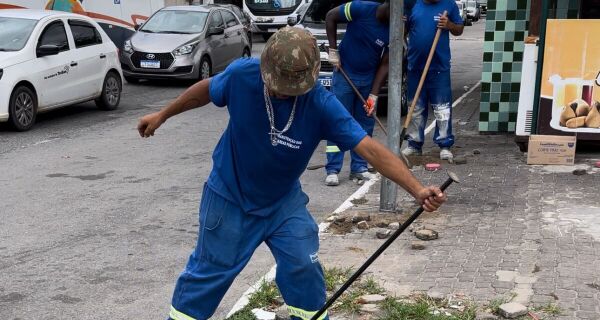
(479, 0, 581, 132)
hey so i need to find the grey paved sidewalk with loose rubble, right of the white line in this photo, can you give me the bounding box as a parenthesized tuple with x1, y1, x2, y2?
(319, 86, 600, 319)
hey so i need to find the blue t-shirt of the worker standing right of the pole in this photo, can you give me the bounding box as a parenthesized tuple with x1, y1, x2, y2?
(408, 0, 463, 71)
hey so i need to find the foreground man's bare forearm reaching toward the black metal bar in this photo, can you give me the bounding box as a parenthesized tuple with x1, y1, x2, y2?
(354, 136, 424, 197)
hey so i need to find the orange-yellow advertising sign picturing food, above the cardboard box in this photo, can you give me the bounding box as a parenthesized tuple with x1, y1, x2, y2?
(538, 19, 600, 140)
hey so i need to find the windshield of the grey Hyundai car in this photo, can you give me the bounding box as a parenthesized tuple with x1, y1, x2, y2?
(140, 10, 208, 34)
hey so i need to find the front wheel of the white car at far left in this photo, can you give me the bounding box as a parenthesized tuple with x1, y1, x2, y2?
(8, 86, 37, 131)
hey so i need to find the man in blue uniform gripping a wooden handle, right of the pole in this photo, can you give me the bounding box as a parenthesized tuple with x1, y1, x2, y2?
(402, 0, 464, 161)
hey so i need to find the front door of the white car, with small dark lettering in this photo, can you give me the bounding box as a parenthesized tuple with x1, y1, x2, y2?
(31, 19, 77, 110)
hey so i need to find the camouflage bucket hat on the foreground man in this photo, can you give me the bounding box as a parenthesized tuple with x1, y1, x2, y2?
(260, 27, 321, 96)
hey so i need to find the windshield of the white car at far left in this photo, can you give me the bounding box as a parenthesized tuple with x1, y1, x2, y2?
(0, 17, 38, 51)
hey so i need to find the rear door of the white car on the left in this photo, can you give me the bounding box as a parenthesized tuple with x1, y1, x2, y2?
(69, 19, 108, 98)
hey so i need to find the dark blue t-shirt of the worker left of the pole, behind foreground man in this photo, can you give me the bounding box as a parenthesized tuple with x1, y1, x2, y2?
(339, 1, 390, 81)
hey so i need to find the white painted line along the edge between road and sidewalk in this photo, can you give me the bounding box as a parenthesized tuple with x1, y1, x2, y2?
(227, 81, 481, 318)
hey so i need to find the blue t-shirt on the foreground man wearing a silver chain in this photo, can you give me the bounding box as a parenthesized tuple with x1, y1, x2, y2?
(208, 58, 367, 216)
